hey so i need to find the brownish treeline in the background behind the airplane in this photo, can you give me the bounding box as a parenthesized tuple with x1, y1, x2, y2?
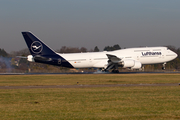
(0, 44, 180, 72)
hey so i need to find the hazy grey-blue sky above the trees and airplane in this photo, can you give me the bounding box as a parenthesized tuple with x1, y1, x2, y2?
(0, 0, 180, 52)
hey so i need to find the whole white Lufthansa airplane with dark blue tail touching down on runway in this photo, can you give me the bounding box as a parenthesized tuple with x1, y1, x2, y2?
(22, 32, 177, 72)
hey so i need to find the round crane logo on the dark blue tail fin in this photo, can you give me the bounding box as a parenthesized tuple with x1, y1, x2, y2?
(31, 41, 43, 54)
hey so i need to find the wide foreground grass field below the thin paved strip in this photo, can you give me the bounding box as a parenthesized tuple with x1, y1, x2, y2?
(0, 86, 180, 120)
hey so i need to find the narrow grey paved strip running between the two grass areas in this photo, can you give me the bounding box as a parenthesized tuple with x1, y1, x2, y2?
(0, 83, 179, 89)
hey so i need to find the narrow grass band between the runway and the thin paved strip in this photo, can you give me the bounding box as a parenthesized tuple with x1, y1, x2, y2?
(0, 74, 180, 86)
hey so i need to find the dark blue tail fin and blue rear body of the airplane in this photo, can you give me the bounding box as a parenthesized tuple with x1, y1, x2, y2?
(22, 32, 73, 68)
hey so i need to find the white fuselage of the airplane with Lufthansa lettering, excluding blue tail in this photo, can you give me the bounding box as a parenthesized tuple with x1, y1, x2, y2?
(57, 47, 177, 68)
